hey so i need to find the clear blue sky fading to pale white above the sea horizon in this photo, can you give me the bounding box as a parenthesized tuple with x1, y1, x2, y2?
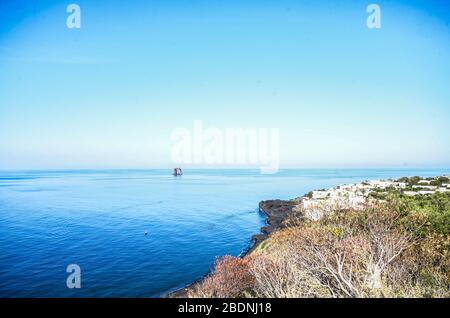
(0, 0, 450, 169)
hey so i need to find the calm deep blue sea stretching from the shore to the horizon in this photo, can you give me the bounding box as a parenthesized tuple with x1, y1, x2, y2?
(0, 169, 450, 297)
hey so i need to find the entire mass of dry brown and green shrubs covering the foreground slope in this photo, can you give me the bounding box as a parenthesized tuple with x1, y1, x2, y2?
(190, 203, 450, 298)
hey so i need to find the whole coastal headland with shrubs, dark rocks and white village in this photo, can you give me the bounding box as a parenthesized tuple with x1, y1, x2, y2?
(175, 176, 450, 298)
